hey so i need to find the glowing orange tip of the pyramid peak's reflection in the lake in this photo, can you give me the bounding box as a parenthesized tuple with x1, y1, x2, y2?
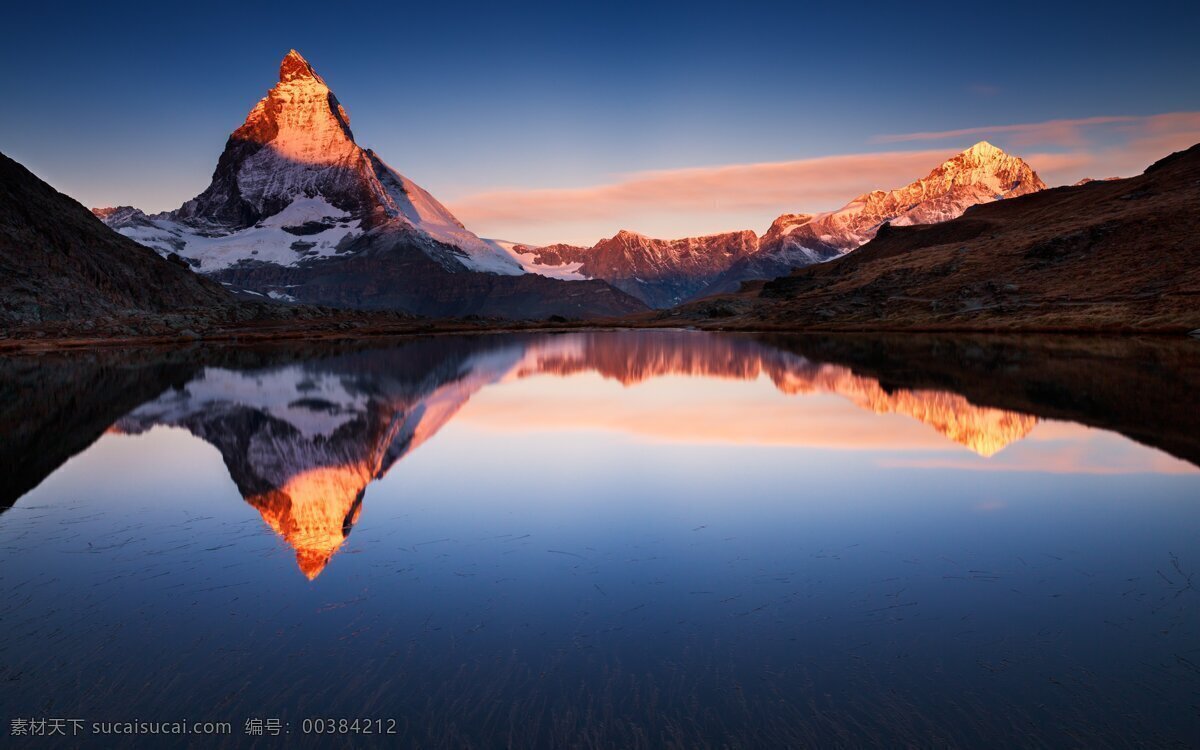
(247, 464, 373, 580)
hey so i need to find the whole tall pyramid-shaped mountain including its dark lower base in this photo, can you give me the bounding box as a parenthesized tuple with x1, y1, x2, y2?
(95, 50, 640, 317)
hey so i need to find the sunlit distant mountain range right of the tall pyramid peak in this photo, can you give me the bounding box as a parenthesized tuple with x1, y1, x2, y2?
(515, 142, 1046, 308)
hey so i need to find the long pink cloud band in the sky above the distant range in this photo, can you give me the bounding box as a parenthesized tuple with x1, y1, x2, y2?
(451, 112, 1200, 244)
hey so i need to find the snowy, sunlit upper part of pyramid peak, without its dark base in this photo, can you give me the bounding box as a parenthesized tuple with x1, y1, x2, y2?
(98, 49, 522, 275)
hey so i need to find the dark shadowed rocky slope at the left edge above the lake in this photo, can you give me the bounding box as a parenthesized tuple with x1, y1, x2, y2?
(0, 154, 234, 332)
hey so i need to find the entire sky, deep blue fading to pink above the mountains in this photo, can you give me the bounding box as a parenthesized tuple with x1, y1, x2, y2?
(0, 0, 1200, 242)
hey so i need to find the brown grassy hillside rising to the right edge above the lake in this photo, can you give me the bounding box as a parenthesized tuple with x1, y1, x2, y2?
(664, 145, 1200, 331)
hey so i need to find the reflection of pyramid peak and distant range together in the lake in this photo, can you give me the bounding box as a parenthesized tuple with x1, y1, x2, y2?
(98, 331, 1037, 578)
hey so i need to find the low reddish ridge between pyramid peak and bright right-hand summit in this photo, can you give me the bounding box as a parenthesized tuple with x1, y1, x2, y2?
(514, 229, 758, 307)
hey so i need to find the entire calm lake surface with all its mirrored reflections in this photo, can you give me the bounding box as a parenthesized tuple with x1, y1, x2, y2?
(0, 331, 1200, 748)
